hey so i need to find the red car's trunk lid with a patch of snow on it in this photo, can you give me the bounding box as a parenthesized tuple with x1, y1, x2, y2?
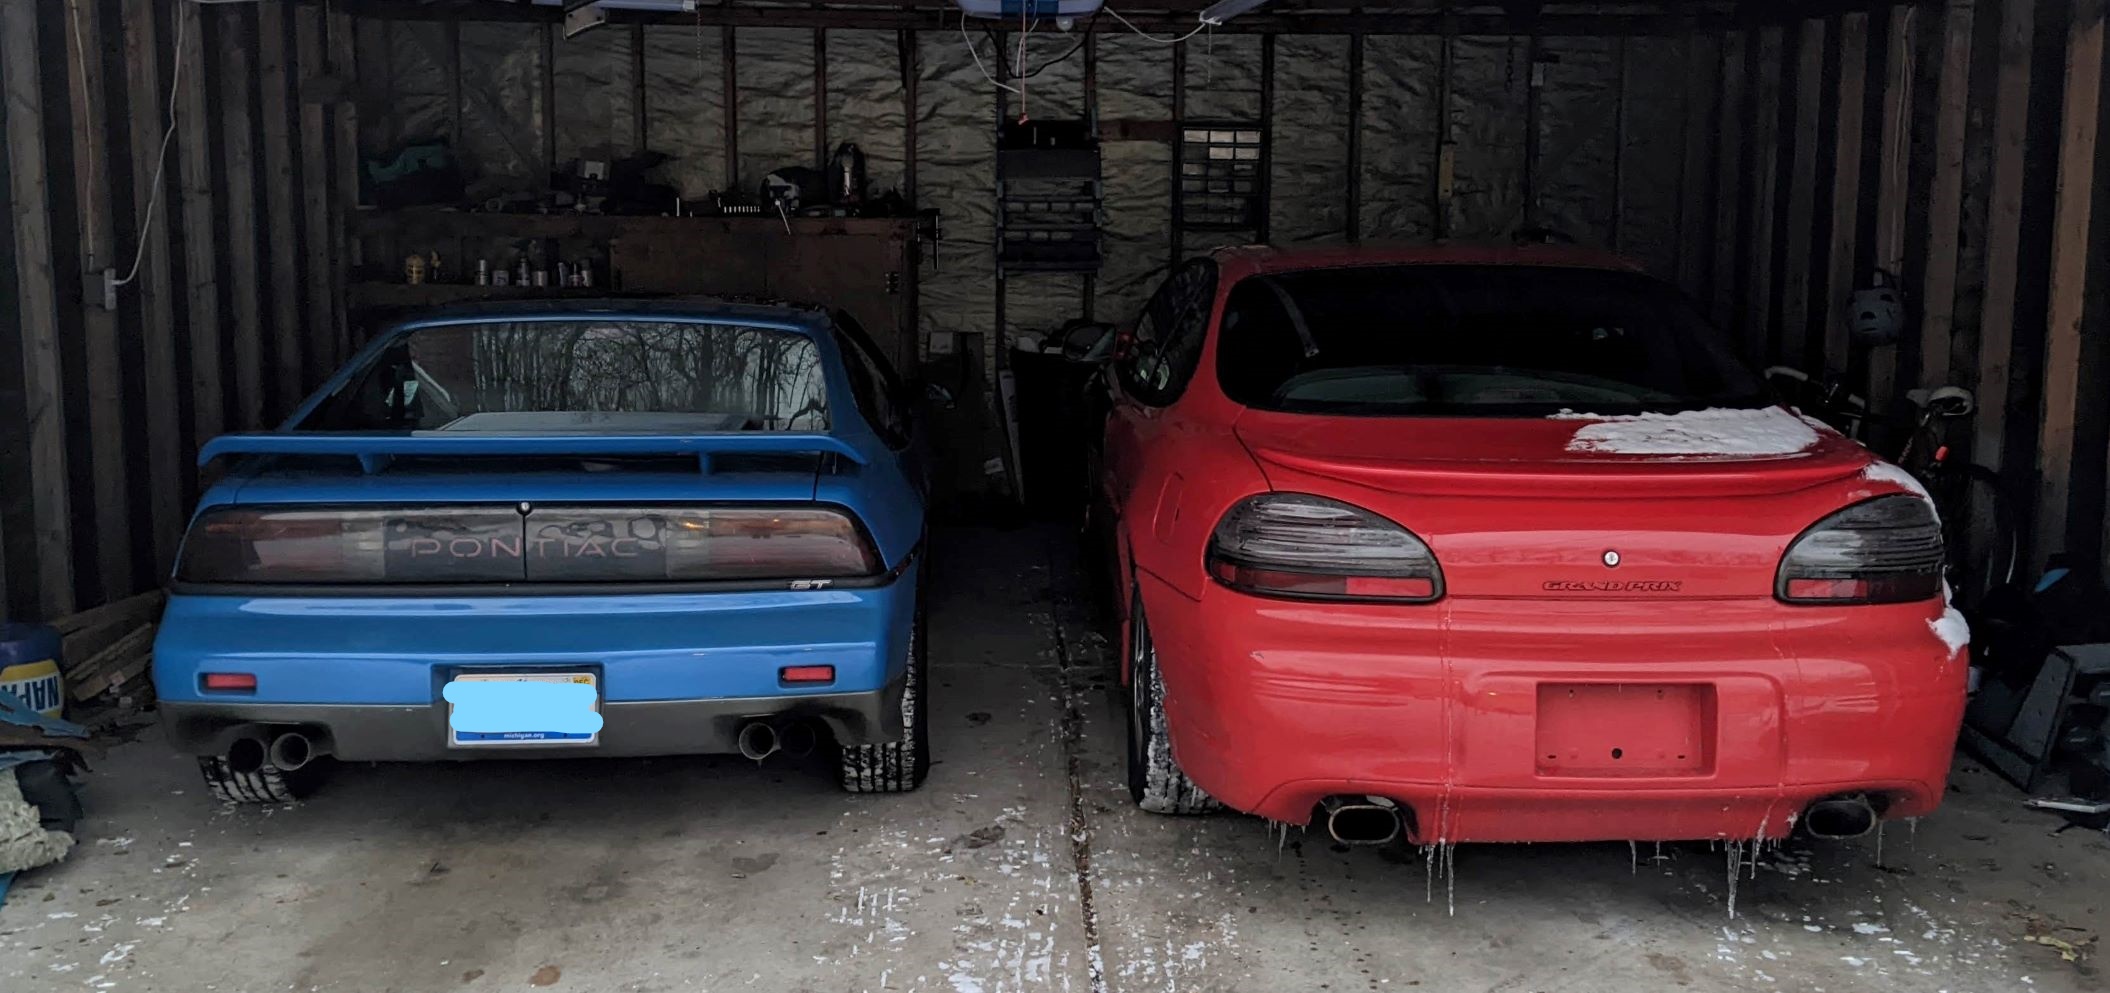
(1236, 407, 1876, 599)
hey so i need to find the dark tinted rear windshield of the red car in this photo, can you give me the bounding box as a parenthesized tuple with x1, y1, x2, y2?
(1217, 266, 1770, 417)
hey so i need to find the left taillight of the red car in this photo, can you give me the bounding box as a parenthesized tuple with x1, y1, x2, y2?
(1207, 493, 1443, 603)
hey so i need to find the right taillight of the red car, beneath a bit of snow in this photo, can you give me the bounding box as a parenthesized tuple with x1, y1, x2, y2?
(1775, 493, 1941, 603)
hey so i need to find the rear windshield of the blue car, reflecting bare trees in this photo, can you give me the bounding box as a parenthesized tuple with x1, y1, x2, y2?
(304, 320, 827, 434)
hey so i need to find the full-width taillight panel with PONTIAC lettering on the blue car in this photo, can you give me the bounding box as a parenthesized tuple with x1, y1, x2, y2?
(175, 504, 882, 584)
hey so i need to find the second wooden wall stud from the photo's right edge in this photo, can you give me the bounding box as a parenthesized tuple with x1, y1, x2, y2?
(1971, 0, 2036, 478)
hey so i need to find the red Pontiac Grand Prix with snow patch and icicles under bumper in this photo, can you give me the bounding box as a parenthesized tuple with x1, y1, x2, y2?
(1097, 247, 1969, 843)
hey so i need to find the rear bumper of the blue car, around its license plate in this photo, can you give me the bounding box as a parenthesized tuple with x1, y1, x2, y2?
(154, 565, 918, 761)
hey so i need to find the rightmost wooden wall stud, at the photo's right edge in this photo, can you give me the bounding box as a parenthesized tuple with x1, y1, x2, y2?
(2030, 0, 2104, 561)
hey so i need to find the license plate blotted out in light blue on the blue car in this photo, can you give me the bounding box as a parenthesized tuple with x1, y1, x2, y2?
(441, 673, 601, 748)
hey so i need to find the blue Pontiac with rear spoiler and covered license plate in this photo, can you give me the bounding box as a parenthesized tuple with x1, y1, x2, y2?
(154, 299, 931, 803)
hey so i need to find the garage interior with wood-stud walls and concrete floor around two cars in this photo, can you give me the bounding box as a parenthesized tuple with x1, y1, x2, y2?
(0, 0, 2110, 993)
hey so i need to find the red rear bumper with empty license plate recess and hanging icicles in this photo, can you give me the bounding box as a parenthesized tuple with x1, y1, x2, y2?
(1142, 576, 1967, 841)
